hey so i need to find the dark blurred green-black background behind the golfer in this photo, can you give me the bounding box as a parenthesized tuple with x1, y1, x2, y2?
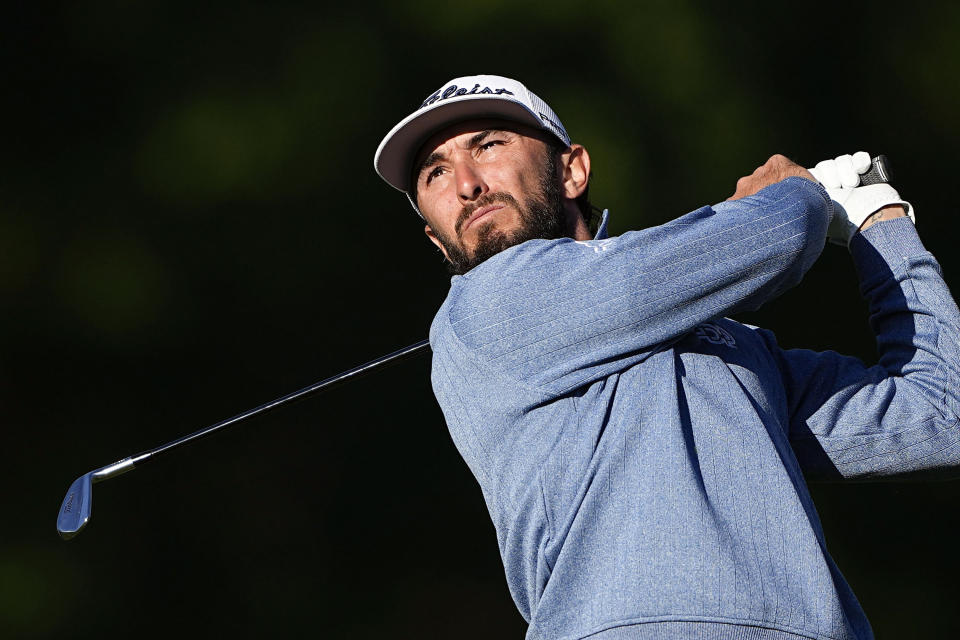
(0, 0, 960, 638)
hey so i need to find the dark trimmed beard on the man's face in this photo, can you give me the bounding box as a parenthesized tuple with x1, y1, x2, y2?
(434, 150, 571, 275)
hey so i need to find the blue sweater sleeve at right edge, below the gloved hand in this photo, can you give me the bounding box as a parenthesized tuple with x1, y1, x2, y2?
(767, 218, 960, 478)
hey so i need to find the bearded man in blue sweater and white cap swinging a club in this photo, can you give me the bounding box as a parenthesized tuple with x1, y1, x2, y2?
(375, 76, 960, 640)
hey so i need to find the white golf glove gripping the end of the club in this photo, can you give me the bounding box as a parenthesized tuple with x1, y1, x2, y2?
(810, 151, 916, 247)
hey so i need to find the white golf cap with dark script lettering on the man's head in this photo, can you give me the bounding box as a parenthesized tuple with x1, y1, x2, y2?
(373, 75, 570, 198)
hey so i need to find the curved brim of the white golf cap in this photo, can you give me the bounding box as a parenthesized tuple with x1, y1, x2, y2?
(373, 94, 552, 192)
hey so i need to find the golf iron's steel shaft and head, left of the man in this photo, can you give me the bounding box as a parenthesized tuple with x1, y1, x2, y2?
(57, 340, 430, 540)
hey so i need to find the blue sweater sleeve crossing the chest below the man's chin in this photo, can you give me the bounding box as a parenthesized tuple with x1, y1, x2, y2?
(442, 178, 831, 395)
